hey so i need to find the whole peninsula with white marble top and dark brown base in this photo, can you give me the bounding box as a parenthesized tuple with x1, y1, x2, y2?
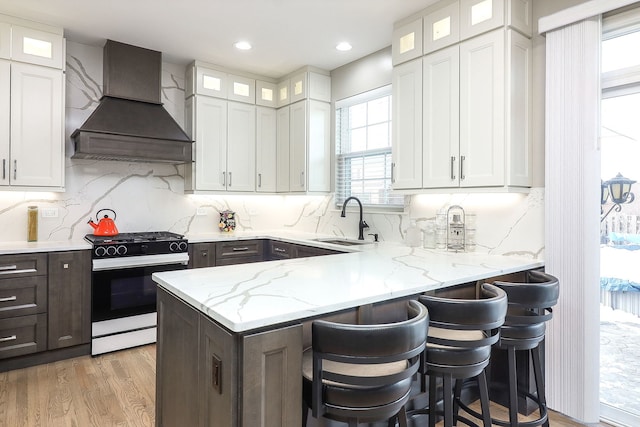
(153, 241, 543, 427)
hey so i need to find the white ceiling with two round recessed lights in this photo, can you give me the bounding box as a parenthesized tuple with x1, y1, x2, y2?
(0, 0, 437, 78)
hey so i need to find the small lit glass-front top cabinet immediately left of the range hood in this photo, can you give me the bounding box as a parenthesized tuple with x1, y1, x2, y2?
(11, 25, 65, 69)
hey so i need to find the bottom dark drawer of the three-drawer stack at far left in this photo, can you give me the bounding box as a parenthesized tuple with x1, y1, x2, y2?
(0, 313, 47, 359)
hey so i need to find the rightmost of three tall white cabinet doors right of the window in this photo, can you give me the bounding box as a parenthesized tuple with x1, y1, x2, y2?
(459, 30, 505, 187)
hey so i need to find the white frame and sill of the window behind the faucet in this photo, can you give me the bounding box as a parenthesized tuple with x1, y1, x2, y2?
(334, 85, 406, 212)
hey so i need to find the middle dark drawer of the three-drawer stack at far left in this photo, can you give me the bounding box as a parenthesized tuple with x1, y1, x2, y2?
(0, 276, 47, 319)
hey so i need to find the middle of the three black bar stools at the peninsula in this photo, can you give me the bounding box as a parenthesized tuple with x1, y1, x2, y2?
(412, 283, 507, 427)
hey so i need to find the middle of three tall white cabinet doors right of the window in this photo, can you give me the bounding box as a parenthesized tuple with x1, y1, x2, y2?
(422, 46, 460, 188)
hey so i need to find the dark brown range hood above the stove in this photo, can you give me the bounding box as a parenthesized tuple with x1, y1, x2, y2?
(71, 40, 193, 163)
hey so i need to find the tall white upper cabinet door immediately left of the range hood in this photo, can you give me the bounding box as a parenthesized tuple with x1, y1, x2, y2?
(9, 63, 64, 187)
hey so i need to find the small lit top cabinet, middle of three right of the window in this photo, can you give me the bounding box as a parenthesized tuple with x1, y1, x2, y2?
(424, 1, 460, 54)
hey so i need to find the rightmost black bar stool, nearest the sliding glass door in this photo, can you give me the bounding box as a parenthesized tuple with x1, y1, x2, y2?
(484, 271, 560, 427)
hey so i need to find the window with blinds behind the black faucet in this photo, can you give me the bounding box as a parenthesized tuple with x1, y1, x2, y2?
(335, 87, 404, 210)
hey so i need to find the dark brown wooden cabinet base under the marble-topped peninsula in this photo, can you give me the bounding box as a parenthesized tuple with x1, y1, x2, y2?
(156, 288, 302, 427)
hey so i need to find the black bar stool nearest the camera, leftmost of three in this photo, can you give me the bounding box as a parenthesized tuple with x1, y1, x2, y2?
(302, 301, 429, 427)
